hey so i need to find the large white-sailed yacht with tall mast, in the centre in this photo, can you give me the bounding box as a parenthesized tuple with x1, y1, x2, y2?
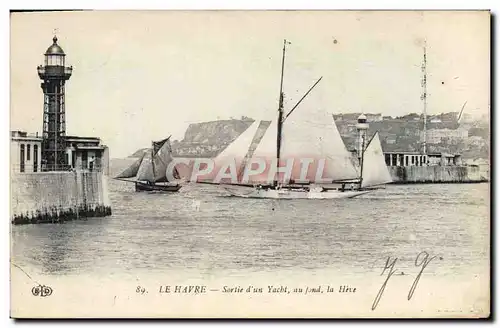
(198, 40, 391, 199)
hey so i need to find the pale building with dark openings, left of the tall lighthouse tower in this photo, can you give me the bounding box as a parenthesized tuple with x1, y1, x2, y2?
(10, 131, 42, 173)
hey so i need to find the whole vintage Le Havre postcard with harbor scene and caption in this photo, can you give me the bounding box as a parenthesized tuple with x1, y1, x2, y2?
(10, 10, 491, 318)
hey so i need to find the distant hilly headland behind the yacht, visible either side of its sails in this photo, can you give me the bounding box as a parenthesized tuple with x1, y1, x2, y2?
(130, 113, 489, 158)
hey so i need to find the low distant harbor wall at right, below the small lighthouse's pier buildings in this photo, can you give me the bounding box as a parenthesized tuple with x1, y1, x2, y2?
(388, 166, 488, 184)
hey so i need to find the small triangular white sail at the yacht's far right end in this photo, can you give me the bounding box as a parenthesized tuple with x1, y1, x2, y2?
(361, 132, 392, 187)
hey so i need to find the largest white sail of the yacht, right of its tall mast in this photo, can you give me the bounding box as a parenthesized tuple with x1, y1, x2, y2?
(281, 108, 359, 183)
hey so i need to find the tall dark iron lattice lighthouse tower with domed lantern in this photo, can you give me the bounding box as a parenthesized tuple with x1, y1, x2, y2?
(37, 36, 73, 171)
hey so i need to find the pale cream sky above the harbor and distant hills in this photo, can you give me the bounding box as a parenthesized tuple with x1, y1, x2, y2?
(10, 11, 490, 158)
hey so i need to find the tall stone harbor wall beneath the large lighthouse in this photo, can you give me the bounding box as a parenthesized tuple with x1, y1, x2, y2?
(10, 171, 111, 224)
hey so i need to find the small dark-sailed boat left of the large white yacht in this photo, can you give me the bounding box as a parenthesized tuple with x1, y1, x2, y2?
(115, 137, 181, 192)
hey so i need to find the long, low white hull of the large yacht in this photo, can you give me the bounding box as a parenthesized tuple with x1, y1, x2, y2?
(224, 187, 371, 199)
